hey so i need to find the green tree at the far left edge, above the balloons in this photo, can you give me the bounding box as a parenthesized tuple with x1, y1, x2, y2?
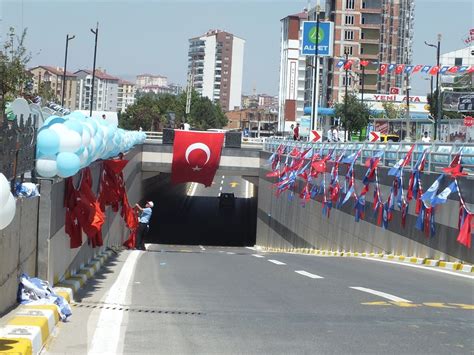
(0, 27, 31, 117)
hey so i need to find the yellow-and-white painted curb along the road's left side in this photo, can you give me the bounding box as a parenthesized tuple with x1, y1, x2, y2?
(0, 249, 115, 355)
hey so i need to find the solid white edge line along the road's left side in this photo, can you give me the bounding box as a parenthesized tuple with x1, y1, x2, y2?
(87, 250, 143, 354)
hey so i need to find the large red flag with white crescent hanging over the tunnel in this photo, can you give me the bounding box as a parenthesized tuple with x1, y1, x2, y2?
(171, 130, 224, 187)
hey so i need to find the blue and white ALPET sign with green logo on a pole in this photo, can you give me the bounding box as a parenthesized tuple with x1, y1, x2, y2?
(301, 21, 334, 57)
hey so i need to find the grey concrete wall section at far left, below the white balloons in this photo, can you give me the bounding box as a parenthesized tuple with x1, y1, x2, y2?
(0, 197, 39, 316)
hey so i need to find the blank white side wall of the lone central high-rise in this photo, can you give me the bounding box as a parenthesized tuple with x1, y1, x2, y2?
(228, 36, 245, 110)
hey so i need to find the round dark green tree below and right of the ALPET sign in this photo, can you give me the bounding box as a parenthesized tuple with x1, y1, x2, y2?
(334, 94, 370, 137)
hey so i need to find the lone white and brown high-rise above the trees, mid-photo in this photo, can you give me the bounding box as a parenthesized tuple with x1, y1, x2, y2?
(188, 30, 245, 111)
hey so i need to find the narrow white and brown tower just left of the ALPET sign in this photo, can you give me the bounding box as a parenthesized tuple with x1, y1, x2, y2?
(278, 12, 308, 131)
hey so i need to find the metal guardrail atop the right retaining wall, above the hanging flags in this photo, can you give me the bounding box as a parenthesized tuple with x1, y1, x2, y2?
(263, 138, 474, 175)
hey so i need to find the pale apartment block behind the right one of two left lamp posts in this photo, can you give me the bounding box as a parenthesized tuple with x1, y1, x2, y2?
(75, 69, 120, 111)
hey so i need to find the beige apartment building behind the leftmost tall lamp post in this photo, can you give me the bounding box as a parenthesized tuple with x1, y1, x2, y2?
(30, 65, 77, 110)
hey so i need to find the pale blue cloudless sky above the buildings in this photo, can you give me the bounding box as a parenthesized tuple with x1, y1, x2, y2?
(0, 0, 474, 95)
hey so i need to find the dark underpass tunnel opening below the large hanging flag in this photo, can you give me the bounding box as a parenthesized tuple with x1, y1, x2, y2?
(145, 174, 258, 247)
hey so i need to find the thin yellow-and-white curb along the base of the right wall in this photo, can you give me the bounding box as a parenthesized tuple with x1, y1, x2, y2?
(262, 245, 474, 273)
